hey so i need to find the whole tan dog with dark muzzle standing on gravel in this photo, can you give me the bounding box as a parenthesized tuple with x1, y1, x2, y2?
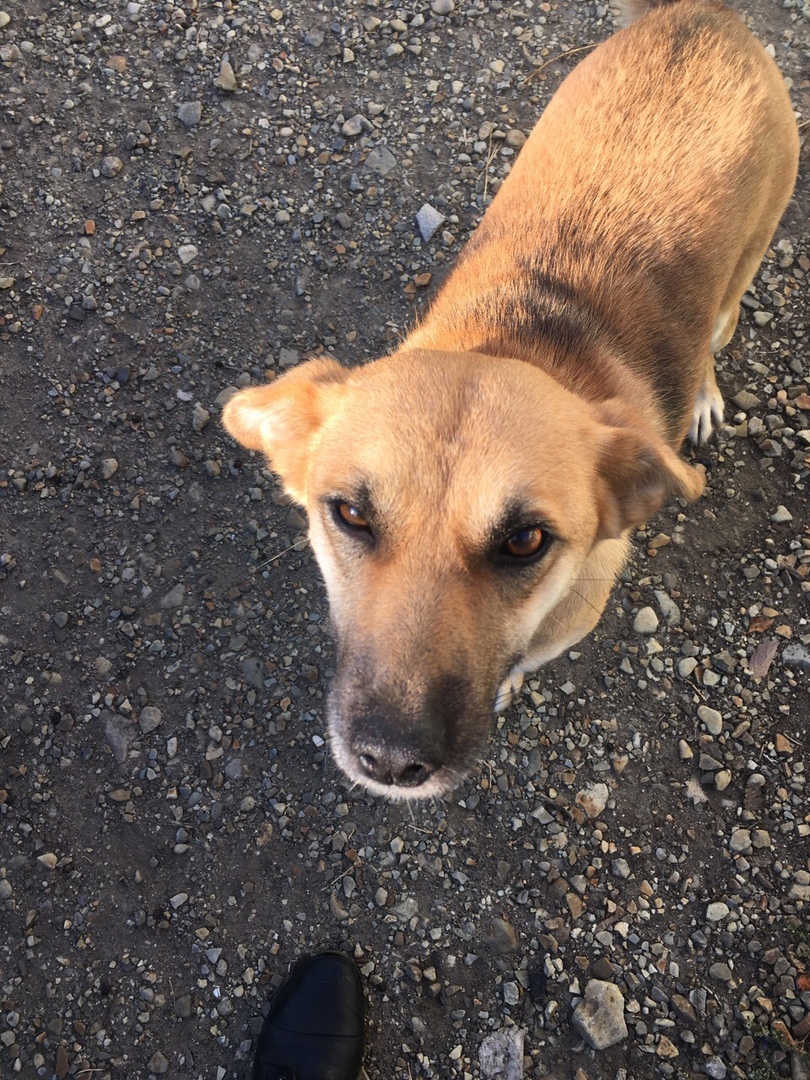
(224, 0, 798, 798)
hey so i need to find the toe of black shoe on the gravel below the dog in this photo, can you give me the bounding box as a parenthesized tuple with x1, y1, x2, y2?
(252, 953, 365, 1080)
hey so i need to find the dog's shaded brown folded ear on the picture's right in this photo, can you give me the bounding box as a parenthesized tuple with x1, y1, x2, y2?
(597, 402, 706, 540)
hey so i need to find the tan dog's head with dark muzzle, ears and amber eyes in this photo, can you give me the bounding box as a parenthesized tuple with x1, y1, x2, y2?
(224, 352, 703, 798)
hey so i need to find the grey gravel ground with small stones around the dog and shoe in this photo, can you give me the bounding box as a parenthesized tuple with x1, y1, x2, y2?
(0, 0, 810, 1080)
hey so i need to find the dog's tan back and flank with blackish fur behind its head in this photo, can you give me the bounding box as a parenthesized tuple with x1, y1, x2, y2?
(406, 0, 798, 446)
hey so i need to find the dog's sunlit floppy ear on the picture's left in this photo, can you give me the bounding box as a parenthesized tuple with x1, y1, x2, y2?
(222, 359, 349, 503)
